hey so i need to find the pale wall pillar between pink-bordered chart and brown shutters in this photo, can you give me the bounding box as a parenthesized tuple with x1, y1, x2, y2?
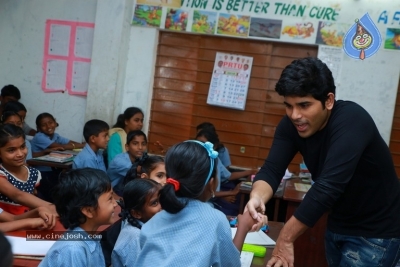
(85, 0, 158, 132)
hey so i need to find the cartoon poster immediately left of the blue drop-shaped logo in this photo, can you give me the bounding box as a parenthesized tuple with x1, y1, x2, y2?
(315, 21, 351, 47)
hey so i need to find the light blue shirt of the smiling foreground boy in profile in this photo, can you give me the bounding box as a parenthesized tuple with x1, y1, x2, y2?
(39, 227, 106, 267)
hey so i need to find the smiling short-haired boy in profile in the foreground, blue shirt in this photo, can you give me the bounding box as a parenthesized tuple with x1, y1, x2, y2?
(39, 168, 117, 267)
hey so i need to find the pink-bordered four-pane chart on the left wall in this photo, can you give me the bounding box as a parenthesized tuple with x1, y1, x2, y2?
(42, 20, 94, 95)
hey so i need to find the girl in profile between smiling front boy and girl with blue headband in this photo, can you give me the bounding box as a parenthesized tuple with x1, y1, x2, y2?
(111, 179, 161, 267)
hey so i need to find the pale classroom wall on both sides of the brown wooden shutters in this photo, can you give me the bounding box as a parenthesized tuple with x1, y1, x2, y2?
(0, 0, 400, 146)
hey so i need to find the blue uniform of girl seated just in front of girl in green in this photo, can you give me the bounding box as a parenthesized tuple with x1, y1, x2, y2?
(107, 152, 132, 191)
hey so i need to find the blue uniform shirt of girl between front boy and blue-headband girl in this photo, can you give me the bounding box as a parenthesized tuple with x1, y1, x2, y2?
(111, 220, 143, 267)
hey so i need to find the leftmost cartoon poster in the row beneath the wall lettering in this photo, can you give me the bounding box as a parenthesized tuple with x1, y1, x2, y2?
(132, 5, 162, 27)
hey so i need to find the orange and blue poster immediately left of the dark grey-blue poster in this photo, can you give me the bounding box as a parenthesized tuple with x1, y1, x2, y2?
(217, 14, 250, 37)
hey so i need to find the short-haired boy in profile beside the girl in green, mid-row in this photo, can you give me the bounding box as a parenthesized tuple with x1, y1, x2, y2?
(72, 120, 110, 172)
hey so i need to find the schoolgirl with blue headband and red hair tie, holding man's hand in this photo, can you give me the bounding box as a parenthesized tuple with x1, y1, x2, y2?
(135, 140, 261, 267)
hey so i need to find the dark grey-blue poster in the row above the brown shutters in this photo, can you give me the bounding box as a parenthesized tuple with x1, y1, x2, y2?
(249, 18, 282, 39)
